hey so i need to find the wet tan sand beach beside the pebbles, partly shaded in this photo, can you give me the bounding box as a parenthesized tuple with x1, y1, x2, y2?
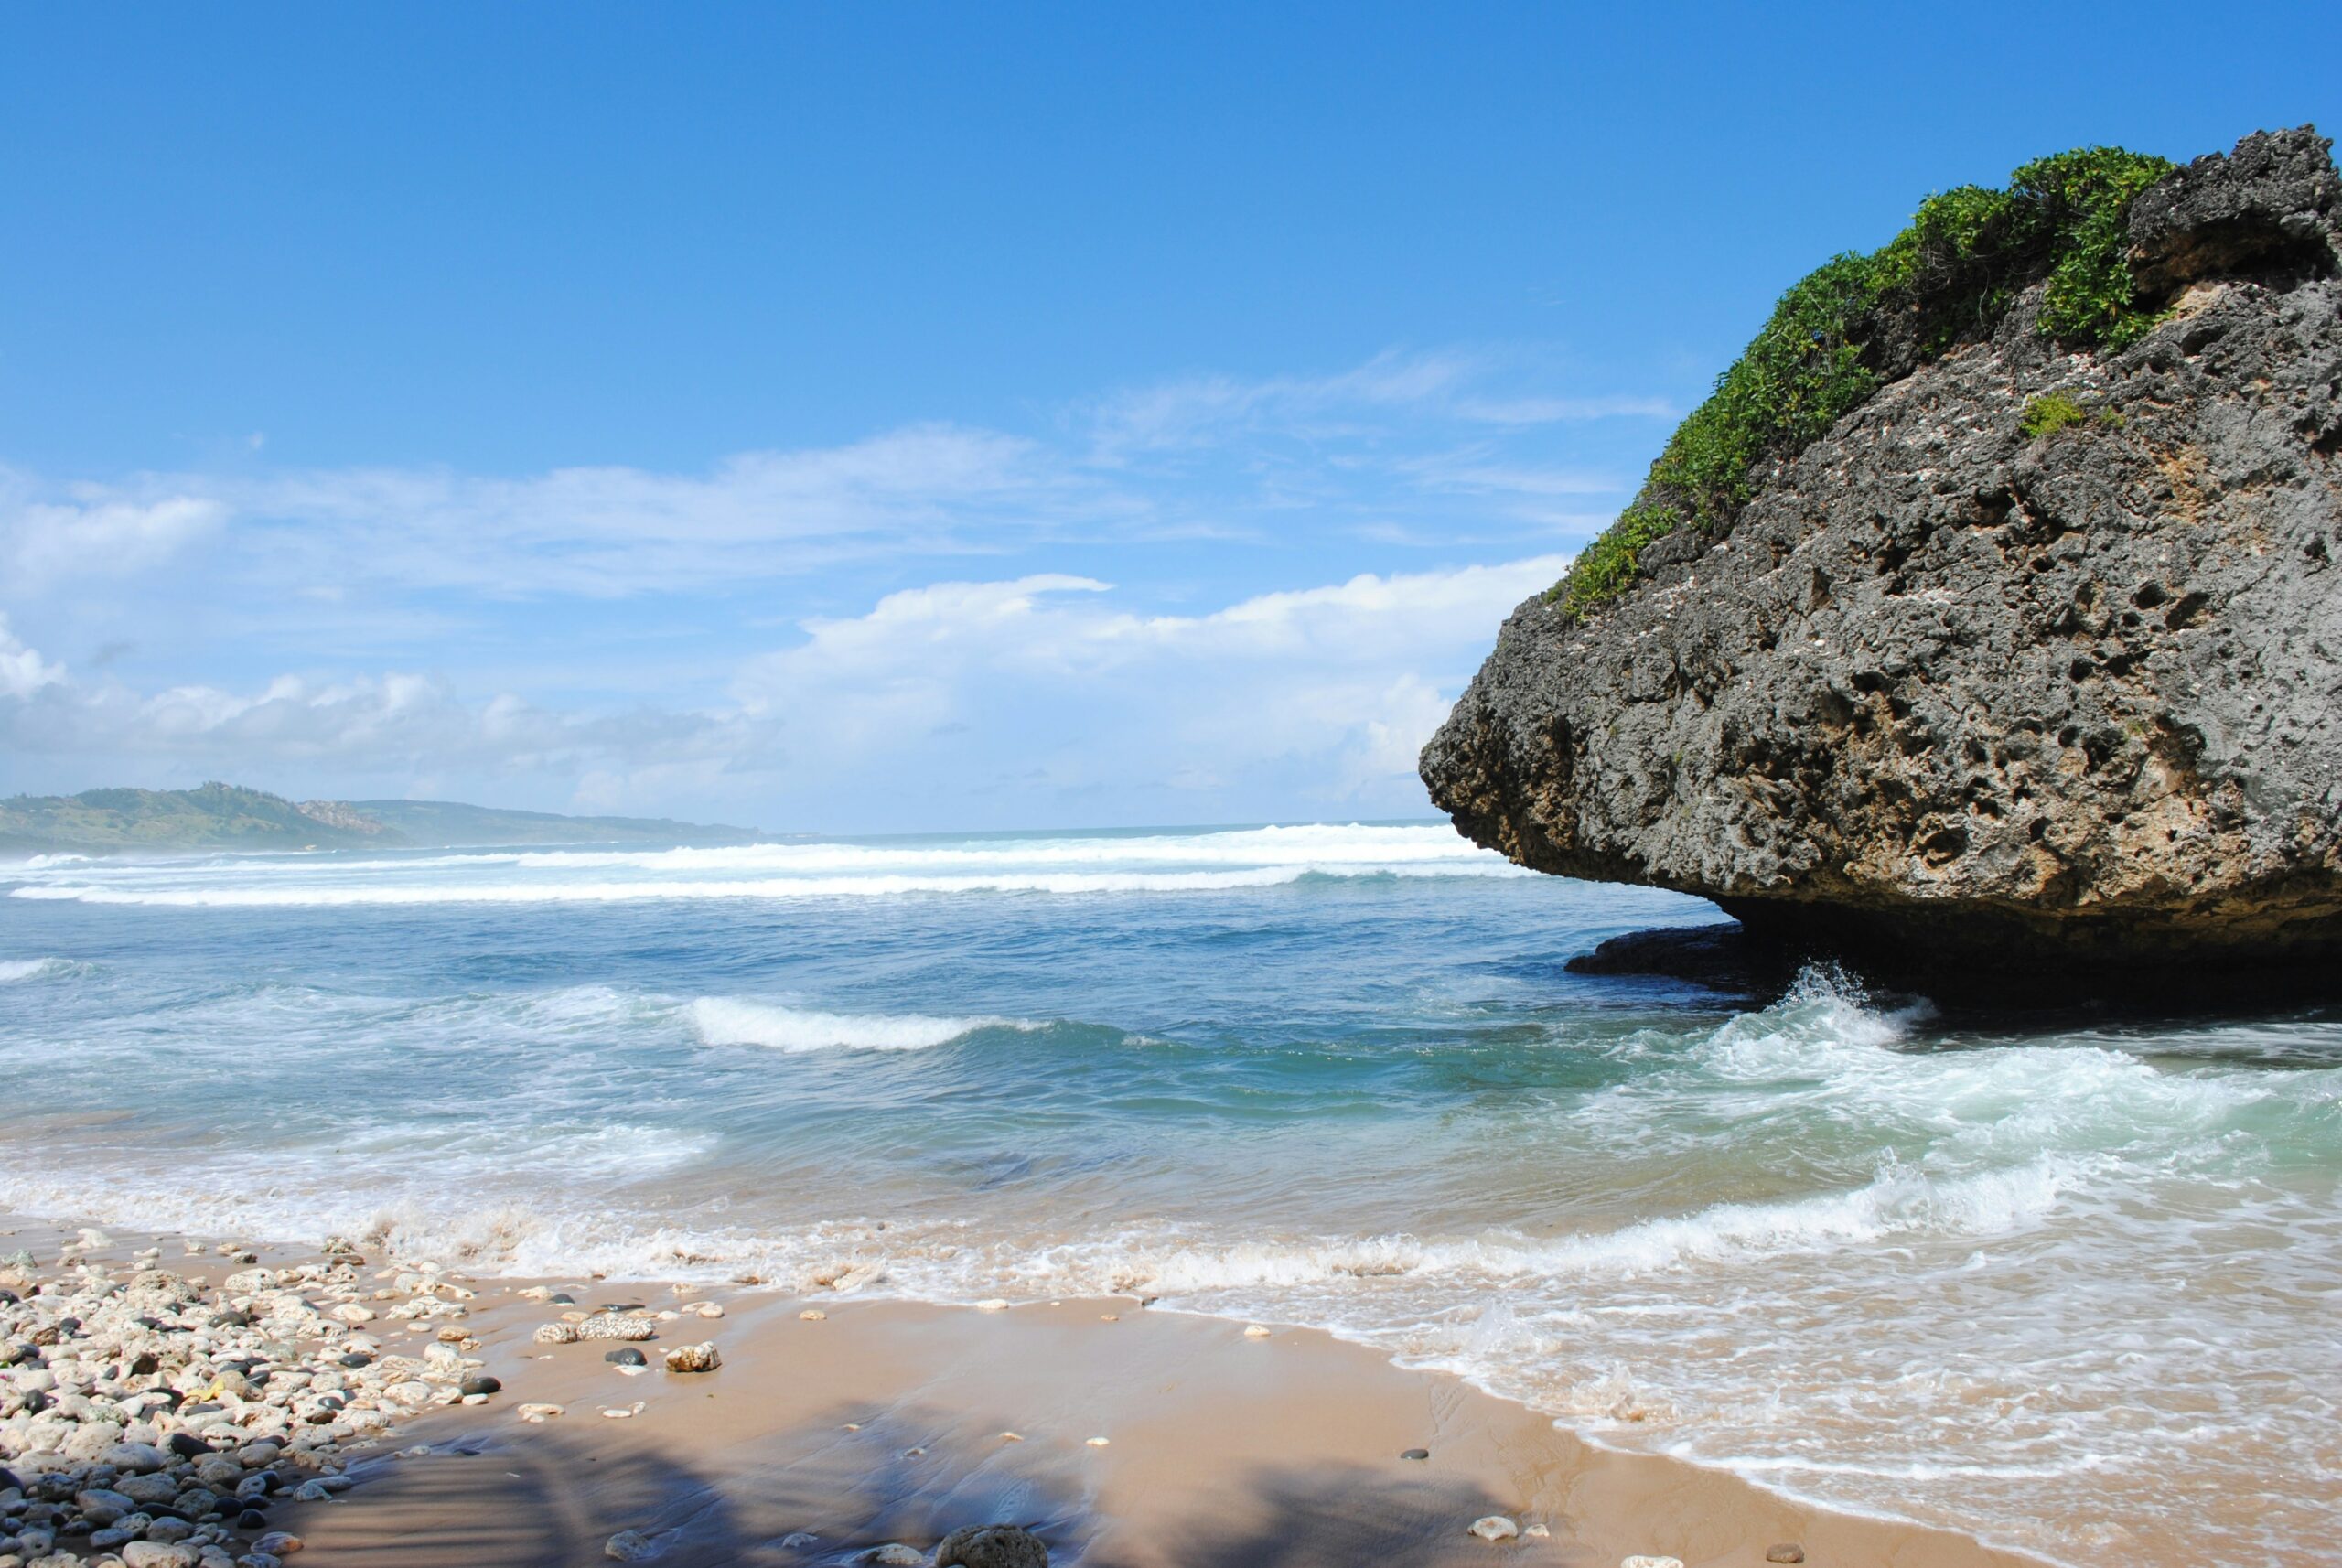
(0, 1217, 2060, 1568)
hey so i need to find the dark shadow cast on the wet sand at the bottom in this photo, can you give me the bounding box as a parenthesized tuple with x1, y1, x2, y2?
(302, 1404, 1504, 1568)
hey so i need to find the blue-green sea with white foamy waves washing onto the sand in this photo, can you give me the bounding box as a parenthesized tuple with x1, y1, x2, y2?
(0, 826, 2342, 1563)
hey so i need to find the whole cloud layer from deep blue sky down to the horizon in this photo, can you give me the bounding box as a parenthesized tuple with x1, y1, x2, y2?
(0, 353, 1672, 831)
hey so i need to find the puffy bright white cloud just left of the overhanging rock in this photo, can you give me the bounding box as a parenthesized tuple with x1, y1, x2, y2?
(736, 554, 1567, 800)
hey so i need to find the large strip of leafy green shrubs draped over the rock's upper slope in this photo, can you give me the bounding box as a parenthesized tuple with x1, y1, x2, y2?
(1548, 147, 2174, 618)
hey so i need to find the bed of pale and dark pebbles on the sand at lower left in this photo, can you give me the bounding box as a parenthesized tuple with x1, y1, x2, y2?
(0, 1231, 497, 1568)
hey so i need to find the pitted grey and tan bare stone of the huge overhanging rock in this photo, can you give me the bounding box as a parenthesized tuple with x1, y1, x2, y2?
(1422, 129, 2342, 983)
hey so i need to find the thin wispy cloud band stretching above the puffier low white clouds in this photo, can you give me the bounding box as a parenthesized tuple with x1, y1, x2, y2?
(0, 351, 1668, 599)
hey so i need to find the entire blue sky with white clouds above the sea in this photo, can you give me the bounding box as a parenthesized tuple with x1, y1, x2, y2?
(0, 0, 2342, 833)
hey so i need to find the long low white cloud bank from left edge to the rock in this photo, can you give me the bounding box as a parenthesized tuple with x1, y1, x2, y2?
(0, 557, 1567, 823)
